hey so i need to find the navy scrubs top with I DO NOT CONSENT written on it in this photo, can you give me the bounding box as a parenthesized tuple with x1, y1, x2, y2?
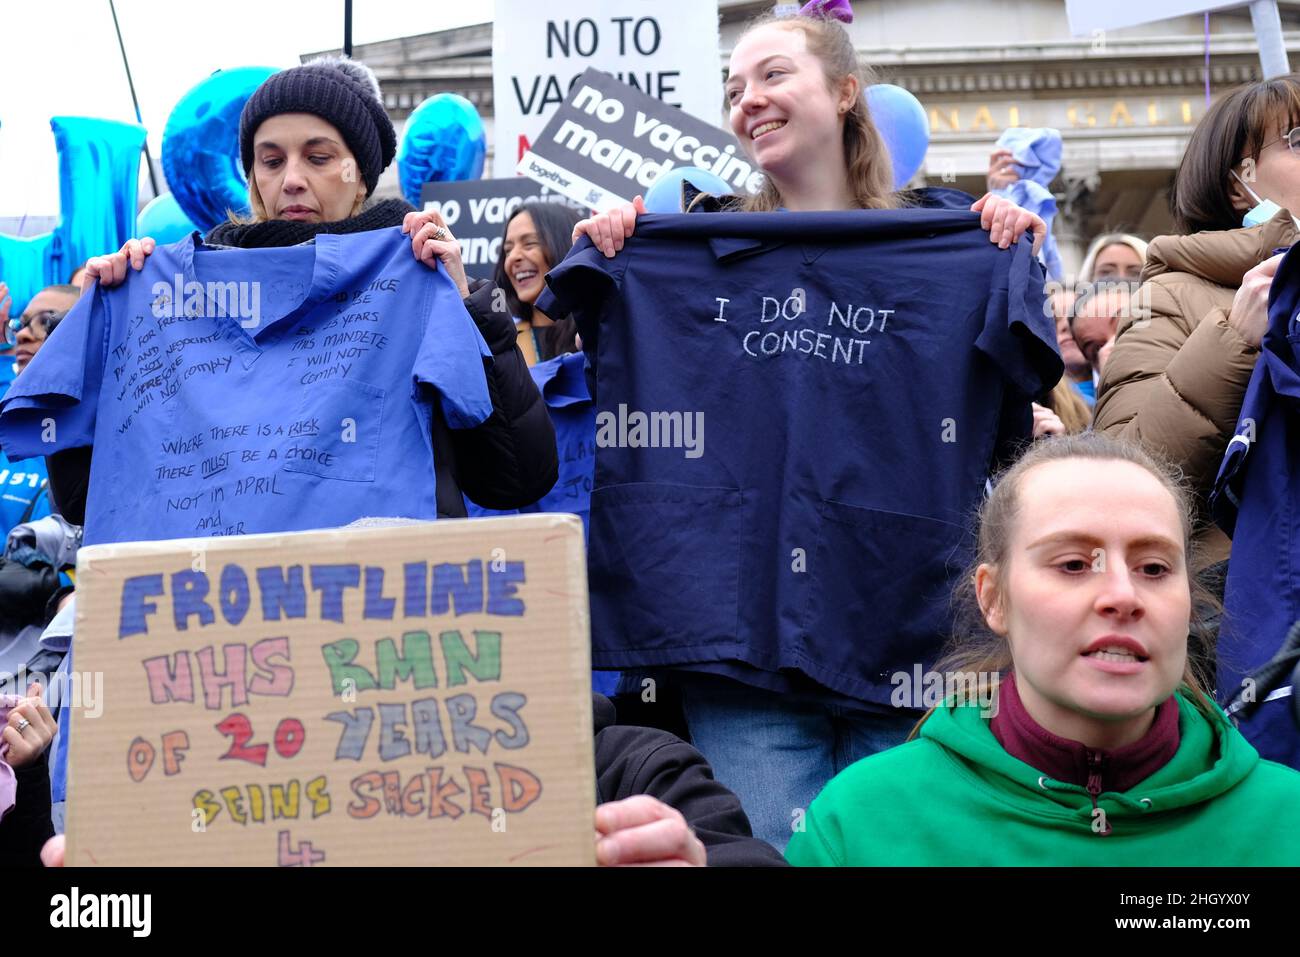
(538, 209, 1062, 705)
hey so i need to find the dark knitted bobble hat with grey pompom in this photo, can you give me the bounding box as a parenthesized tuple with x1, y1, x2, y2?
(239, 57, 398, 196)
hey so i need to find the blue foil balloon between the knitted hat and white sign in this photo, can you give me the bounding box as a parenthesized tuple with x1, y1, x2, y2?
(398, 94, 488, 207)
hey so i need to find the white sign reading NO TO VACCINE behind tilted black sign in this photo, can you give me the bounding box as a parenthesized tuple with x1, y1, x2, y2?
(491, 0, 722, 177)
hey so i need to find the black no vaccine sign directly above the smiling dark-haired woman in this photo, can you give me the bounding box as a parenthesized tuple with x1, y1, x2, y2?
(420, 176, 588, 280)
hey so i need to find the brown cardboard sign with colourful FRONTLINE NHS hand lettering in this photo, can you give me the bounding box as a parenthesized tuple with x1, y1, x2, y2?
(66, 515, 595, 866)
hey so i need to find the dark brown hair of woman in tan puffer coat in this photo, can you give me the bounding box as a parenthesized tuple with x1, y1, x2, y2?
(1169, 73, 1300, 235)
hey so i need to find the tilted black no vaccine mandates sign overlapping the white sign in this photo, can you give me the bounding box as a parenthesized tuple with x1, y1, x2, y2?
(519, 70, 763, 212)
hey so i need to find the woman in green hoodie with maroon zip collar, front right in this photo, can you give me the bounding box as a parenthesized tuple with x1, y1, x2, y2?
(787, 433, 1300, 866)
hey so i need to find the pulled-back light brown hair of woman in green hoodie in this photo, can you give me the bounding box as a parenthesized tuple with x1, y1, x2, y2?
(911, 432, 1216, 737)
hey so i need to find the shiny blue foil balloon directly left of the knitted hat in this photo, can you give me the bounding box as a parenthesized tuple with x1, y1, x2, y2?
(163, 66, 278, 231)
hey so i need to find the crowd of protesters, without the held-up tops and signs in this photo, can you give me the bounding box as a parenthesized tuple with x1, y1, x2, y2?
(0, 4, 1300, 866)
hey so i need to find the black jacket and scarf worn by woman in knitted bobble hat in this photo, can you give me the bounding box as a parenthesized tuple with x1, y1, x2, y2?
(46, 199, 559, 525)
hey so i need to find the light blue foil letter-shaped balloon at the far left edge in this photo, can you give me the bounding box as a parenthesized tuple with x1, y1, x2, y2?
(0, 116, 144, 316)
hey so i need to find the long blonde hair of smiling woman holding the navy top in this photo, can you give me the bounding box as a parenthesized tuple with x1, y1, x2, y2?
(741, 14, 901, 212)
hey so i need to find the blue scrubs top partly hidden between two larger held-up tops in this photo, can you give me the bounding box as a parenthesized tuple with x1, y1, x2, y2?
(465, 352, 619, 694)
